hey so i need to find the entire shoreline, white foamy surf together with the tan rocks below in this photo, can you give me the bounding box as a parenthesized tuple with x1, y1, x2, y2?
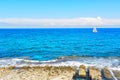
(0, 57, 120, 80)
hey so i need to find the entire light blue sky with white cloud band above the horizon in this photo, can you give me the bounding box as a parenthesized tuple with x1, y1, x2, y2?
(0, 0, 120, 28)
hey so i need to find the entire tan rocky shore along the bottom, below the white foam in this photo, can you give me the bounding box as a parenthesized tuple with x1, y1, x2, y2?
(0, 65, 120, 80)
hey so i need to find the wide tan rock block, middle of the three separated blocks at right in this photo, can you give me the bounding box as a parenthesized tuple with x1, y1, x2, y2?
(89, 67, 102, 80)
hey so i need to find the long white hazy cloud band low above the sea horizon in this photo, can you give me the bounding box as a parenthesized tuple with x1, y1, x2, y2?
(0, 17, 120, 28)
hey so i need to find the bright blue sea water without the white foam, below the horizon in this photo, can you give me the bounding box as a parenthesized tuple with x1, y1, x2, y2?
(0, 28, 120, 67)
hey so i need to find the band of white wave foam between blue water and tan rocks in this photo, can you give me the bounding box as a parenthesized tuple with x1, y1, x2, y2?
(0, 57, 120, 70)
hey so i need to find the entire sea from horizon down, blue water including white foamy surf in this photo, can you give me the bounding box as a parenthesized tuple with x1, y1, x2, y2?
(0, 28, 120, 70)
